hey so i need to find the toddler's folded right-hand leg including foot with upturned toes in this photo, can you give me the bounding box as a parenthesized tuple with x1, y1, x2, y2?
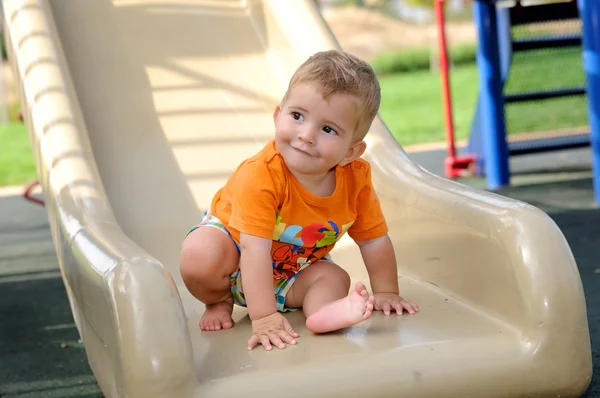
(286, 260, 373, 333)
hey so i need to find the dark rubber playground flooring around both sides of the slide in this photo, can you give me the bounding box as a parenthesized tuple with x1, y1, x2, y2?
(0, 149, 600, 398)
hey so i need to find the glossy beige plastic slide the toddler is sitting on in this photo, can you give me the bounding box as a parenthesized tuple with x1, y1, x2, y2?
(2, 0, 592, 398)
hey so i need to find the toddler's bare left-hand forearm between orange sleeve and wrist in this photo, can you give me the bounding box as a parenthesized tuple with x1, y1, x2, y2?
(240, 233, 277, 321)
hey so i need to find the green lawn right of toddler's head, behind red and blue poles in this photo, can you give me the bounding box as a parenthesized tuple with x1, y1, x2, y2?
(380, 48, 587, 145)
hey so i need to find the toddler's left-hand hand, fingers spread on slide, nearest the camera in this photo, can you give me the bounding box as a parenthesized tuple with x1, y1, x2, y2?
(248, 312, 300, 351)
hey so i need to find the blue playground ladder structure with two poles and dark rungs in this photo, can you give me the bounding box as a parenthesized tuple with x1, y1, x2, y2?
(466, 0, 600, 204)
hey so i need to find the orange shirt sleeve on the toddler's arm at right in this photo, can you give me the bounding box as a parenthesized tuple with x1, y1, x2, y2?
(348, 162, 388, 240)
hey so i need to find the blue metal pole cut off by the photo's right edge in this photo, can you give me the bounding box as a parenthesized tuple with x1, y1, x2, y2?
(578, 0, 600, 204)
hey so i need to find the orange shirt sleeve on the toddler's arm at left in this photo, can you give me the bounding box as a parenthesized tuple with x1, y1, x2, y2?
(229, 161, 283, 239)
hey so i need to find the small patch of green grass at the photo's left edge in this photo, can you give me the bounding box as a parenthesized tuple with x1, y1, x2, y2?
(0, 122, 37, 186)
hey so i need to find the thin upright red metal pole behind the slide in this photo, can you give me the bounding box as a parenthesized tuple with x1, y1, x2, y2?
(435, 0, 456, 159)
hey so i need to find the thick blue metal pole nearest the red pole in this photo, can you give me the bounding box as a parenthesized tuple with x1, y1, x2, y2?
(473, 0, 510, 189)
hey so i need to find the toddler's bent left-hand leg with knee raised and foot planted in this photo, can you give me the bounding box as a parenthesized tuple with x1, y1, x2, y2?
(179, 226, 240, 330)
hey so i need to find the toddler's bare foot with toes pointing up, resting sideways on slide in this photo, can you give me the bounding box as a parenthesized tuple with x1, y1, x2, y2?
(306, 282, 375, 333)
